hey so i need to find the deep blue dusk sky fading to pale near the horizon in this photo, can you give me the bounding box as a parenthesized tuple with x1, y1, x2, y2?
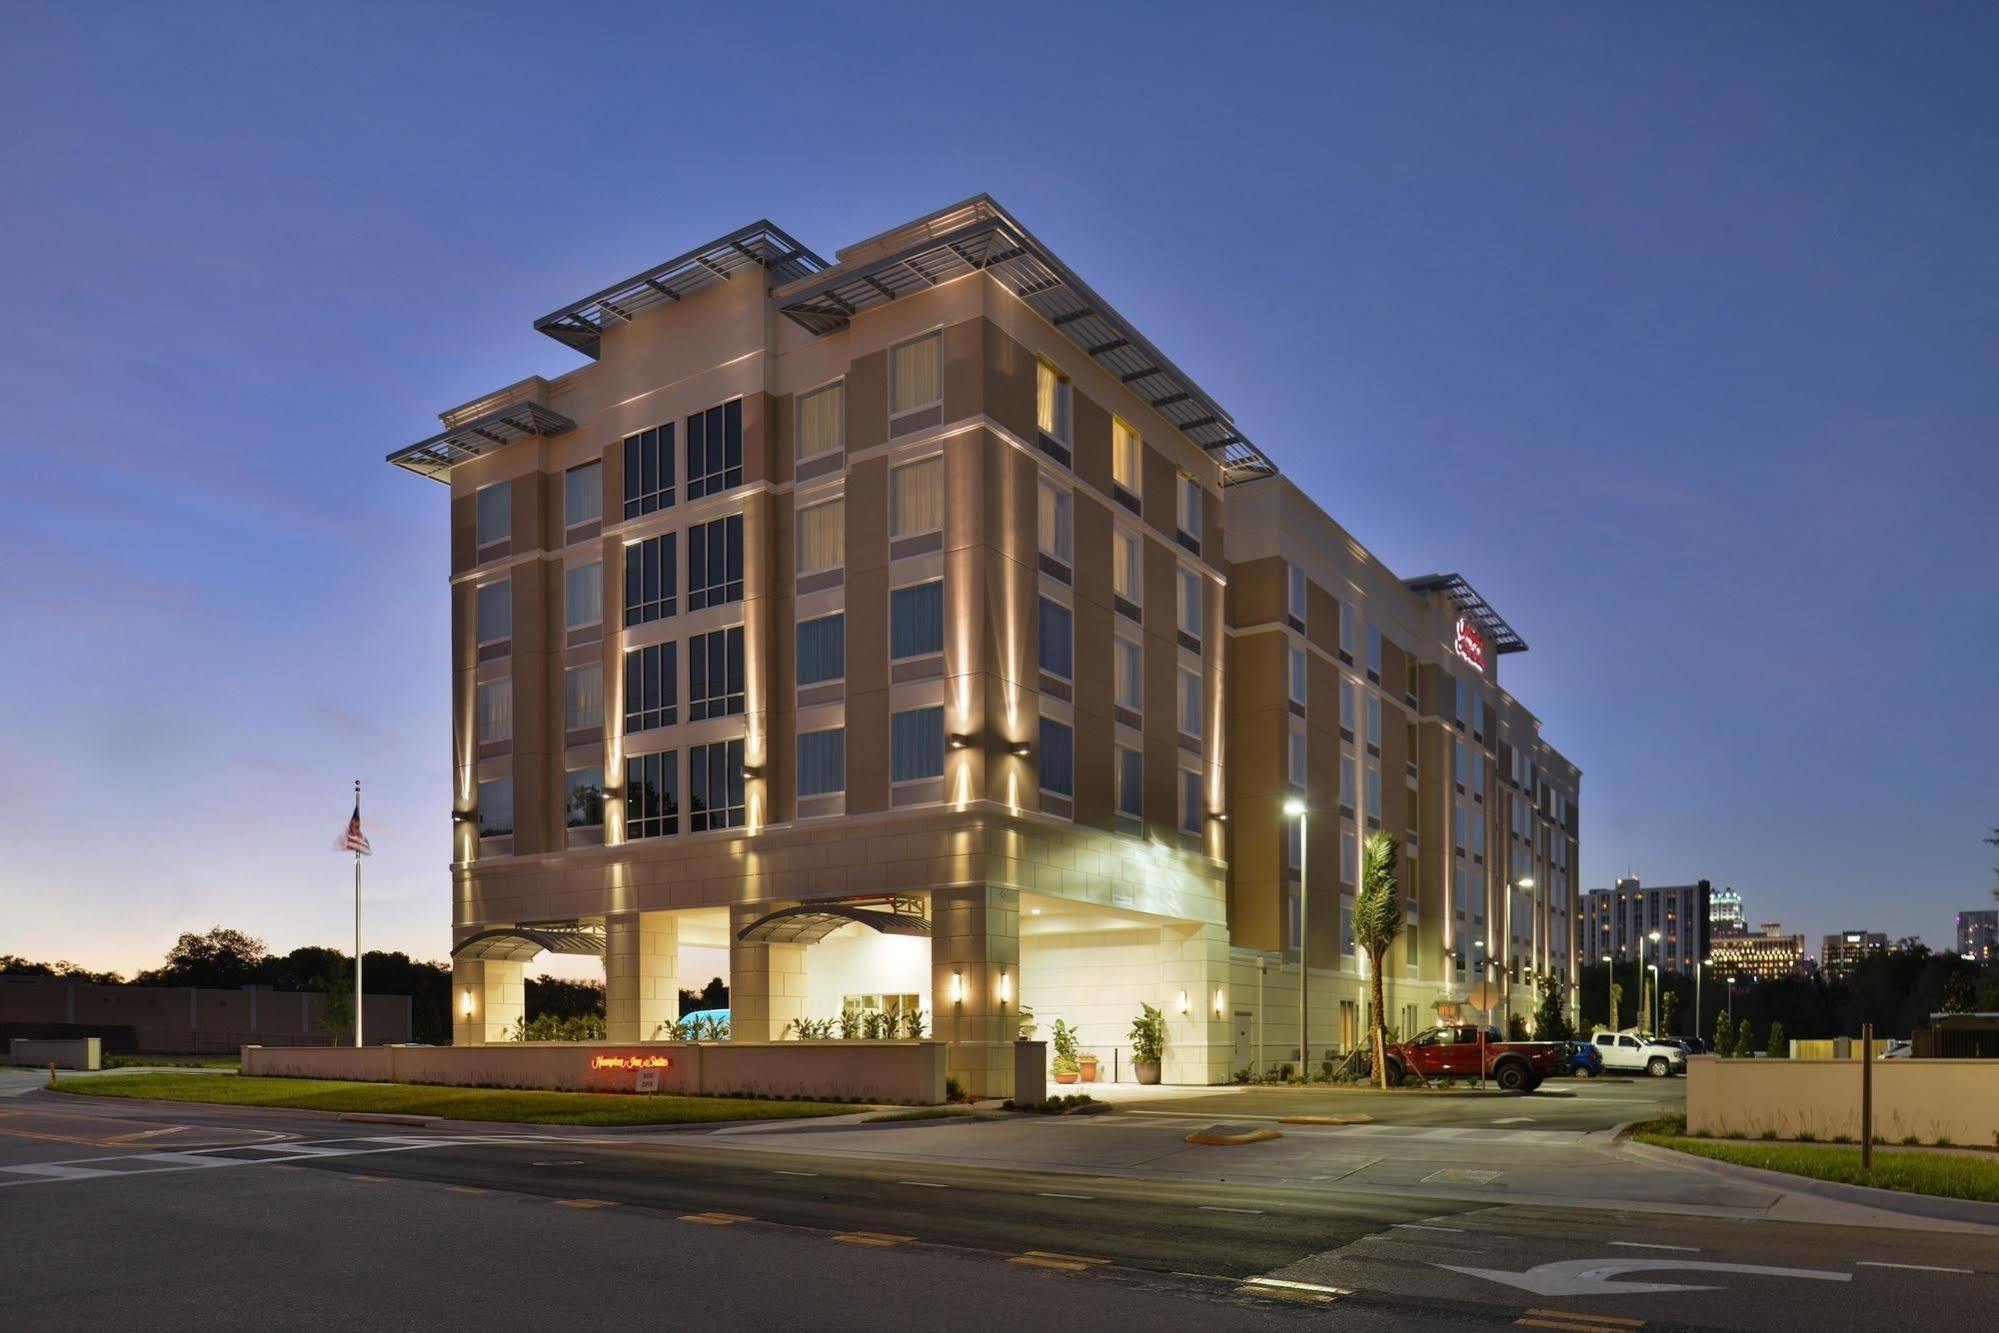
(0, 2, 1999, 973)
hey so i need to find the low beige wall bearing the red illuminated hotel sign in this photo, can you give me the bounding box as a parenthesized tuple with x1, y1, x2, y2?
(242, 1041, 946, 1105)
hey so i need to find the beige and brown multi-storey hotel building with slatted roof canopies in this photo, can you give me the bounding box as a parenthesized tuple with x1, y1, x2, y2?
(390, 196, 1579, 1095)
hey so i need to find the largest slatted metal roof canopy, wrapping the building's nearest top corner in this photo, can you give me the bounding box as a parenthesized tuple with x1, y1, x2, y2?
(778, 194, 1277, 486)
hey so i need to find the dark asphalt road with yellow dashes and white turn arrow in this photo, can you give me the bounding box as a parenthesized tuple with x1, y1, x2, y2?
(0, 1085, 1999, 1329)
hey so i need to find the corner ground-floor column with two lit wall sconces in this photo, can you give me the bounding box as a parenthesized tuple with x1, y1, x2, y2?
(930, 885, 1019, 1097)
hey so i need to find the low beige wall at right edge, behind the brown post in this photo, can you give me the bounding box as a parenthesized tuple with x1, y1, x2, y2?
(1687, 1055, 1999, 1147)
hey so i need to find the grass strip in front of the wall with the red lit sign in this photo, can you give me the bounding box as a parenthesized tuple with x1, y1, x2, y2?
(56, 1073, 860, 1125)
